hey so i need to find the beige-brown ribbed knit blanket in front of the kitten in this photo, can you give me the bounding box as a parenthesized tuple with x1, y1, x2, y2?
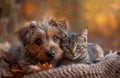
(25, 53, 120, 78)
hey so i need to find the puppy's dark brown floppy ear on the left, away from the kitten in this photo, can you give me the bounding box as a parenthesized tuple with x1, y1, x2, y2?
(17, 21, 36, 46)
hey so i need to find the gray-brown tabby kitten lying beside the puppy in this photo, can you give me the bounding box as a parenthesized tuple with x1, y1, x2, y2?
(61, 29, 104, 65)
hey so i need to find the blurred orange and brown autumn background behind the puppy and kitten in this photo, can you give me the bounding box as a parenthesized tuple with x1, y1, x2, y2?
(0, 0, 120, 50)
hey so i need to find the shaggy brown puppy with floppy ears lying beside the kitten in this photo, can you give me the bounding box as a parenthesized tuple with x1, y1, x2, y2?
(8, 19, 69, 73)
